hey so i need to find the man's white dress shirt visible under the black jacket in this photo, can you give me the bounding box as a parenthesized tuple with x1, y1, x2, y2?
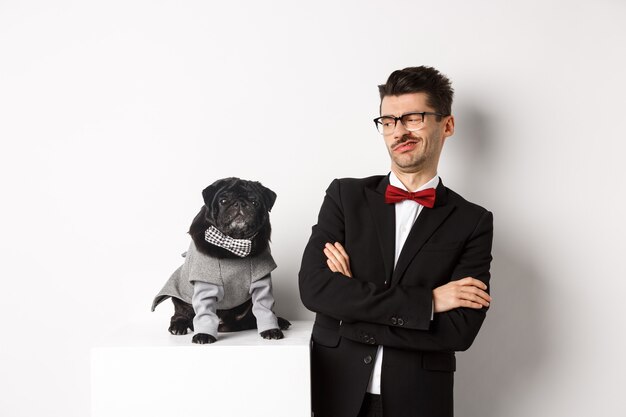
(367, 171, 439, 394)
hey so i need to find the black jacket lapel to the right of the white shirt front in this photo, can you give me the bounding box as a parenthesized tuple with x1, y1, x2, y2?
(390, 180, 454, 284)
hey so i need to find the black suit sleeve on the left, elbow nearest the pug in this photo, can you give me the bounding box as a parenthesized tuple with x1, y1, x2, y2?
(299, 180, 432, 329)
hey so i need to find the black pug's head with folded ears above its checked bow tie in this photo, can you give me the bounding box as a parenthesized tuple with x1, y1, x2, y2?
(202, 178, 276, 239)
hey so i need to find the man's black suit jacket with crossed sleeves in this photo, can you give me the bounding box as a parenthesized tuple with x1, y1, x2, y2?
(299, 176, 493, 417)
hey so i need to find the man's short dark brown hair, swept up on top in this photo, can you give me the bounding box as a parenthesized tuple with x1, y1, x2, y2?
(378, 66, 454, 119)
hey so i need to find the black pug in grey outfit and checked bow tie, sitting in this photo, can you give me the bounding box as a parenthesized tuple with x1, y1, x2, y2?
(152, 177, 291, 344)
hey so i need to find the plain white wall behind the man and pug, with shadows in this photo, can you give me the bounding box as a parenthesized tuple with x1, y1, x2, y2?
(0, 0, 626, 417)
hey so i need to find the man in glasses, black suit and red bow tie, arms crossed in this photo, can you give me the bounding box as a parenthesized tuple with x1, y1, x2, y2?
(299, 67, 493, 417)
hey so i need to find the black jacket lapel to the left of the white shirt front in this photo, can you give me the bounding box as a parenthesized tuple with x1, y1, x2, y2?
(365, 176, 396, 282)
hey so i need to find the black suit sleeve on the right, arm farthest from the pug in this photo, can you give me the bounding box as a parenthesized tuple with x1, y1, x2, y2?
(340, 211, 493, 351)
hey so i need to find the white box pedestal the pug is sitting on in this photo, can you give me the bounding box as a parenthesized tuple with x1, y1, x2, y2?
(91, 314, 313, 417)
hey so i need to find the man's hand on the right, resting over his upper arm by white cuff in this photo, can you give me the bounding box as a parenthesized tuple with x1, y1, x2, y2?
(433, 277, 491, 313)
